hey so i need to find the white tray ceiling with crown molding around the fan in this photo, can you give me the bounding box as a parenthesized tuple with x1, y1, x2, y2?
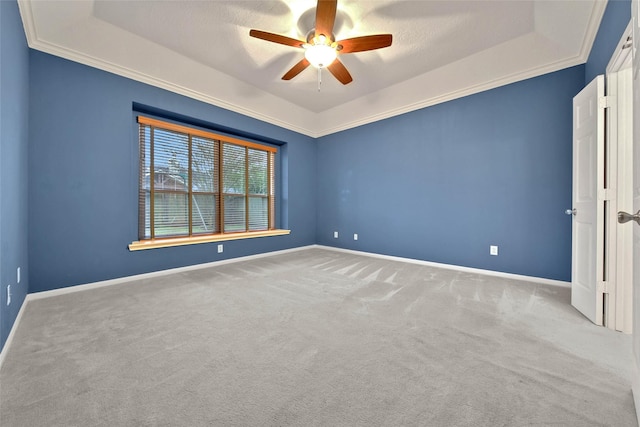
(19, 0, 606, 137)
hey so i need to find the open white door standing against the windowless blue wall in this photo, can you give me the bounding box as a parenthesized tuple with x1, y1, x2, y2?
(571, 76, 604, 325)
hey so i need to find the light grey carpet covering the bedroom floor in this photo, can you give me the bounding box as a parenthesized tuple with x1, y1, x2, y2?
(0, 248, 637, 427)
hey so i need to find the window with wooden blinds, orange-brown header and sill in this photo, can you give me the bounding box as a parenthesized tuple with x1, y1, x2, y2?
(129, 116, 288, 250)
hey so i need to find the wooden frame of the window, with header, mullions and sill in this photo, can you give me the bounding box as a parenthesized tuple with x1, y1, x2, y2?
(129, 115, 291, 251)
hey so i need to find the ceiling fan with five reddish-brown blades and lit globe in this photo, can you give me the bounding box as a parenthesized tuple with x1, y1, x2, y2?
(249, 0, 392, 85)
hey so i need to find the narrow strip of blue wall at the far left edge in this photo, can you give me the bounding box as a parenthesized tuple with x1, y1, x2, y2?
(0, 1, 29, 349)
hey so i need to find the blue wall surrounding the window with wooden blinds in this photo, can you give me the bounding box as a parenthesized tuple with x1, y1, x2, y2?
(29, 51, 316, 292)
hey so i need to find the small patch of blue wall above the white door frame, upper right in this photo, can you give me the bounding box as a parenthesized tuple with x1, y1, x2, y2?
(585, 0, 631, 83)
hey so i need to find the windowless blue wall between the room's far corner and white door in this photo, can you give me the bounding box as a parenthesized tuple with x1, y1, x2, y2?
(318, 66, 584, 281)
